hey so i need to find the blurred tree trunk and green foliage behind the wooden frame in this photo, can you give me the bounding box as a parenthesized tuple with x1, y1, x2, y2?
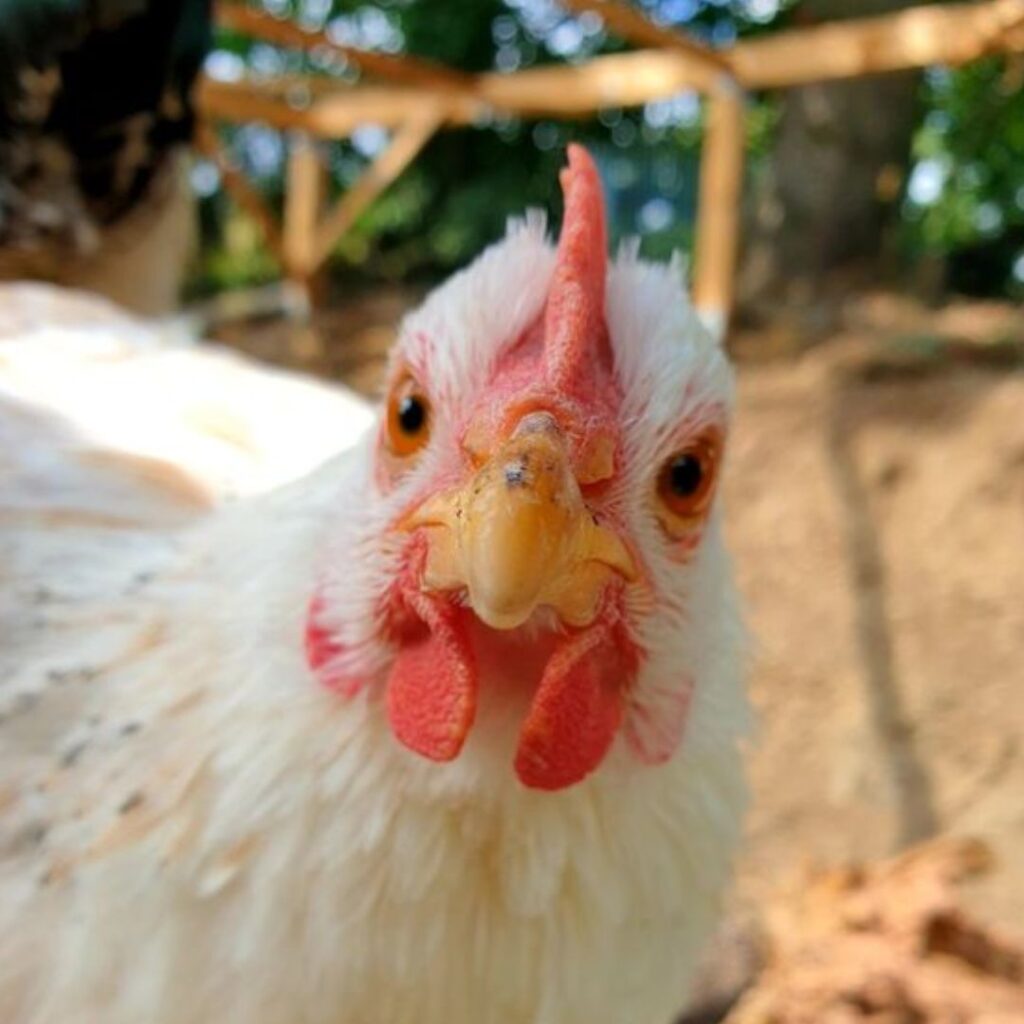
(197, 0, 1024, 304)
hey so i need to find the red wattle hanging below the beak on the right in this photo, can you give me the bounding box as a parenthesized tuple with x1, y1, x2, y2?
(515, 626, 630, 790)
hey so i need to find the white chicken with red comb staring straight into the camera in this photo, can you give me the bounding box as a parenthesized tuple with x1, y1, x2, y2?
(0, 146, 748, 1024)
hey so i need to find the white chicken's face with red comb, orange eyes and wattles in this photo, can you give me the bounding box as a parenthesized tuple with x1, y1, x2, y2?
(307, 146, 731, 790)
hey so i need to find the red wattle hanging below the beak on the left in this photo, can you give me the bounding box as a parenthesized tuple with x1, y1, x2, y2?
(387, 593, 477, 761)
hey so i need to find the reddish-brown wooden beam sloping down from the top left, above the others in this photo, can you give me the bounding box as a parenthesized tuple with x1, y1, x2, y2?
(215, 2, 472, 89)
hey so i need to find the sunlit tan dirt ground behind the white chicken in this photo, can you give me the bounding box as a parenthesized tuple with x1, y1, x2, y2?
(216, 284, 1024, 928)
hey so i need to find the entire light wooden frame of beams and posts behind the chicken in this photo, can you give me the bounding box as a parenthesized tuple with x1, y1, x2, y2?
(197, 0, 1024, 327)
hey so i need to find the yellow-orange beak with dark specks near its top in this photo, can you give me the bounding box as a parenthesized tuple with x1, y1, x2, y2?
(402, 412, 637, 630)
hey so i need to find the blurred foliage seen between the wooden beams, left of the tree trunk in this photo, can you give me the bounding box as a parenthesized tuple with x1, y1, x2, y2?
(199, 0, 786, 287)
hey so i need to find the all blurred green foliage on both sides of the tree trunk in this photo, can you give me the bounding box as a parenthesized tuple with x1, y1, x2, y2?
(198, 0, 1024, 299)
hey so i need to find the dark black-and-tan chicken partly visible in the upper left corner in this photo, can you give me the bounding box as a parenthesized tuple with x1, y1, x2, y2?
(0, 0, 212, 313)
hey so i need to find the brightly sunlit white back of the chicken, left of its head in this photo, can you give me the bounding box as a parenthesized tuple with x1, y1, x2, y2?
(0, 283, 373, 503)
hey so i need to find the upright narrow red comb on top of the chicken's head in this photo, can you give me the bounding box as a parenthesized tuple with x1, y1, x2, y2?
(544, 143, 607, 391)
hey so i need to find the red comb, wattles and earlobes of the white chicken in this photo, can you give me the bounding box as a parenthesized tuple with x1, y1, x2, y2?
(306, 146, 689, 790)
